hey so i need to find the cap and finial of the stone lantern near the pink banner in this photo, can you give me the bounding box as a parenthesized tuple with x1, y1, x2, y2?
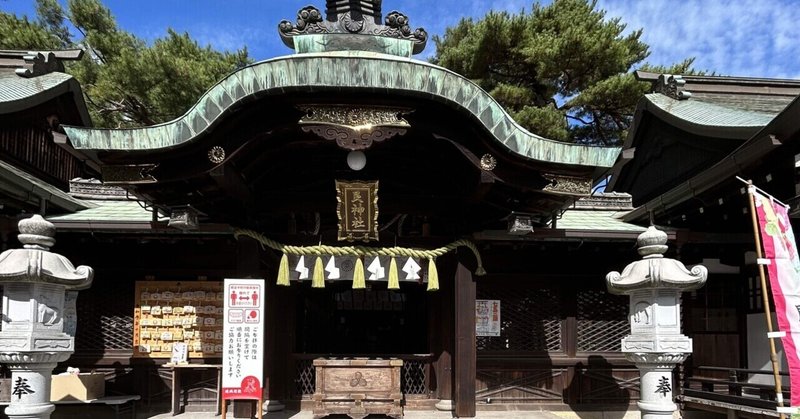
(606, 226, 708, 295)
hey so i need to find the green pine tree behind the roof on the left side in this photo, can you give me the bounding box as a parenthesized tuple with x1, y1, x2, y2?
(0, 0, 252, 127)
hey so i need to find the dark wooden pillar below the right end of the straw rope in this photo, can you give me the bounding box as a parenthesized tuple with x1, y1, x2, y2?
(453, 261, 477, 418)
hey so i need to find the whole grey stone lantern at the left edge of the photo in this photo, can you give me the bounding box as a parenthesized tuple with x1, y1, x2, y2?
(0, 215, 94, 419)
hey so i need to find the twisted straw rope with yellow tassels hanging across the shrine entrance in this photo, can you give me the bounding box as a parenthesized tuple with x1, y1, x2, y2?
(233, 229, 486, 291)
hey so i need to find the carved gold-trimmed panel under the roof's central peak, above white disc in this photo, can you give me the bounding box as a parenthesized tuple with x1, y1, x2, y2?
(299, 105, 411, 150)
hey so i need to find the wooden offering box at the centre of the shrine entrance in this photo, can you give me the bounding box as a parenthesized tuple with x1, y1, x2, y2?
(314, 358, 403, 419)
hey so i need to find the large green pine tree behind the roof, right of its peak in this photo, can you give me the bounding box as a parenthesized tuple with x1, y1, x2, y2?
(432, 0, 693, 145)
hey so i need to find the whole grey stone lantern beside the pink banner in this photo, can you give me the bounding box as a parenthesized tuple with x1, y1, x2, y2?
(606, 226, 708, 419)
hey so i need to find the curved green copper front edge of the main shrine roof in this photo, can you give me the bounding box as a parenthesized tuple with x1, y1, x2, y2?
(65, 51, 620, 167)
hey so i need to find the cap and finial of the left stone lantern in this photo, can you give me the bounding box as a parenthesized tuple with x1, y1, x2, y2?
(0, 214, 94, 290)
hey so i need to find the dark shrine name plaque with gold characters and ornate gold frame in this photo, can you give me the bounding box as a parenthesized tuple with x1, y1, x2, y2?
(336, 180, 378, 241)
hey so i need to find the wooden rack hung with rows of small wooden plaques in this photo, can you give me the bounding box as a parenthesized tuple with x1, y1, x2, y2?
(133, 281, 223, 358)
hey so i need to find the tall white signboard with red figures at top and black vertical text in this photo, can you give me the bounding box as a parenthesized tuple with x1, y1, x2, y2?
(222, 279, 264, 400)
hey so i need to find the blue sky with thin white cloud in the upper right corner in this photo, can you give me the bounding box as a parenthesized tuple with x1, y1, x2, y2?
(598, 0, 800, 78)
